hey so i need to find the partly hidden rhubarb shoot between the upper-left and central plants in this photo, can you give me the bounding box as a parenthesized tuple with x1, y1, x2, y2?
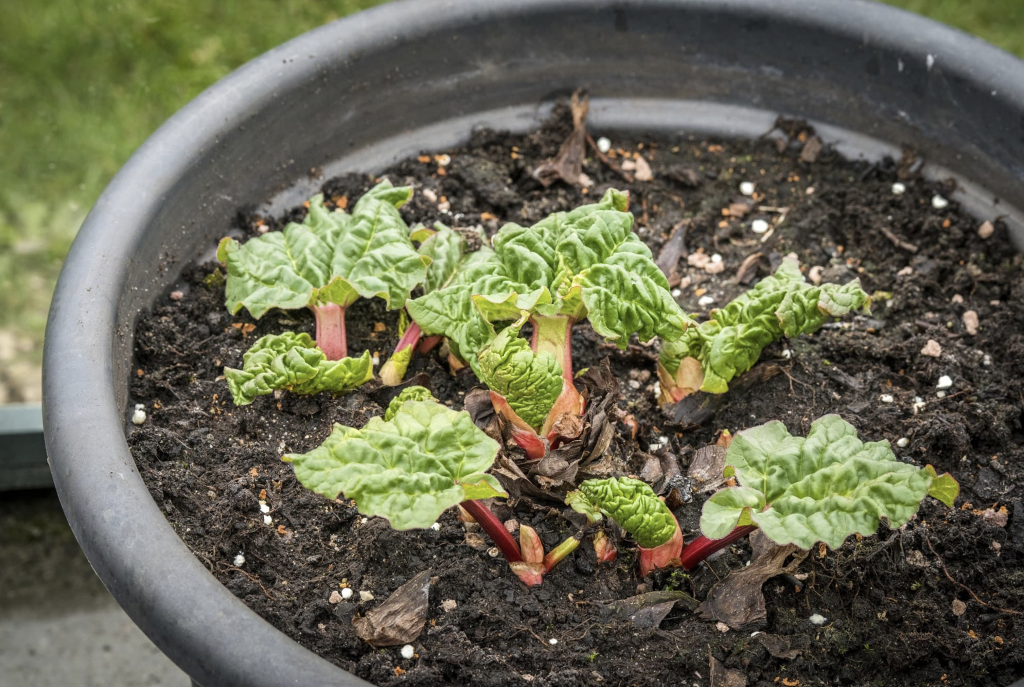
(380, 222, 494, 386)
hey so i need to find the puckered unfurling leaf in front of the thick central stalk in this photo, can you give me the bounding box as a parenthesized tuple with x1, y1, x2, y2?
(478, 321, 564, 430)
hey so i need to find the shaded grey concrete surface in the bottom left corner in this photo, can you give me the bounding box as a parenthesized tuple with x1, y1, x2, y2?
(0, 490, 190, 687)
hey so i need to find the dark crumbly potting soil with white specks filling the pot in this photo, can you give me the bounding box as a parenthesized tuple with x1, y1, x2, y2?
(129, 108, 1024, 687)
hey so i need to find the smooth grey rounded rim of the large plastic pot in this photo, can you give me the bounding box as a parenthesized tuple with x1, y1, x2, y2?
(43, 0, 1024, 687)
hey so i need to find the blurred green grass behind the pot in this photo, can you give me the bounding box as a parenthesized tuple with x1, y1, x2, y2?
(0, 0, 1024, 403)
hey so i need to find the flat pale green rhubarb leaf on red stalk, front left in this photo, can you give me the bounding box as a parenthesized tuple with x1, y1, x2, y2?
(284, 400, 506, 529)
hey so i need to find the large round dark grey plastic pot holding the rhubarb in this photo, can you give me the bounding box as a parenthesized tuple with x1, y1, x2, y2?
(44, 0, 1024, 687)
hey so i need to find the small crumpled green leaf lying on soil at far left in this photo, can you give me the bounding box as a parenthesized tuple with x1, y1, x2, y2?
(224, 332, 374, 405)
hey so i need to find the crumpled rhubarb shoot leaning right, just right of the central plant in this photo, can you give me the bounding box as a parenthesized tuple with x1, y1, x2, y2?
(657, 259, 870, 403)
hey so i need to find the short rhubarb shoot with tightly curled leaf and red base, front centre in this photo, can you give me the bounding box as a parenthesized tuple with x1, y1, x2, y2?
(565, 477, 683, 576)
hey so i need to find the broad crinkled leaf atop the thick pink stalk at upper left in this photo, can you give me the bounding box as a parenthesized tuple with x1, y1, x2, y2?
(217, 180, 430, 318)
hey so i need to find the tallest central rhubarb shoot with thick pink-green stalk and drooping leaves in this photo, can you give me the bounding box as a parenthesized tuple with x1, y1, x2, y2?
(408, 189, 690, 459)
